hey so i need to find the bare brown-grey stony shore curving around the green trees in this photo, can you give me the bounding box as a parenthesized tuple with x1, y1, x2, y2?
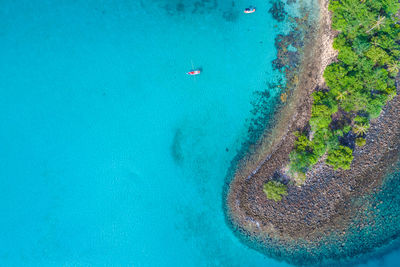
(226, 0, 400, 265)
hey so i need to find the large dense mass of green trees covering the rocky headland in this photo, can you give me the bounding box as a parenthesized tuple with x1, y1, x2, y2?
(290, 0, 400, 180)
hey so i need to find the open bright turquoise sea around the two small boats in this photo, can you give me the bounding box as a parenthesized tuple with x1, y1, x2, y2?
(0, 0, 399, 266)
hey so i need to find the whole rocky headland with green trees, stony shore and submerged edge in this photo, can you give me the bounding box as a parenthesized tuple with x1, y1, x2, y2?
(225, 0, 400, 265)
